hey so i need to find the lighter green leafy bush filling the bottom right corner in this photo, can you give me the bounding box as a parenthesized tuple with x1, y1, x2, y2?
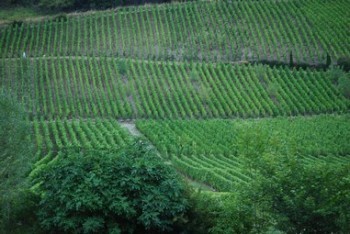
(239, 154, 350, 233)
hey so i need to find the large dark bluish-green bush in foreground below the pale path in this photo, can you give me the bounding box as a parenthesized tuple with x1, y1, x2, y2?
(34, 141, 187, 233)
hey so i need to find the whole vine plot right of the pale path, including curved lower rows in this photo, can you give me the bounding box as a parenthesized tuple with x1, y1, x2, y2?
(136, 115, 350, 191)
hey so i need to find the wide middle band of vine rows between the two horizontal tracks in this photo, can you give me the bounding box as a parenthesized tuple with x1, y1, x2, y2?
(0, 57, 350, 119)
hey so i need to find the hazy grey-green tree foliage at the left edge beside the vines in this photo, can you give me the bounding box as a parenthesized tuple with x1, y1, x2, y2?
(0, 89, 33, 228)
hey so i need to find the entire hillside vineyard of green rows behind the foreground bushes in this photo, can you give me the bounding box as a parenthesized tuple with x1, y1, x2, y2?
(0, 0, 350, 230)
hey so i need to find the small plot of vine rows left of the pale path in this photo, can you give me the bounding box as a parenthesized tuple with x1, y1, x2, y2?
(33, 119, 132, 153)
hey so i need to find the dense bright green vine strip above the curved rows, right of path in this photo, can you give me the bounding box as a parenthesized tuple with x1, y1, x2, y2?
(136, 115, 350, 156)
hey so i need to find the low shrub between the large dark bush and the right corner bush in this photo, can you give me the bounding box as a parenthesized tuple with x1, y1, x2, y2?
(187, 190, 273, 234)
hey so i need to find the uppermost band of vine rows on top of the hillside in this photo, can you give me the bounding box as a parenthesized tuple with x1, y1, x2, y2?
(0, 0, 350, 64)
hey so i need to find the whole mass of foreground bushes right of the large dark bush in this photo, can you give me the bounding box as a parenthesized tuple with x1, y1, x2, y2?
(191, 154, 350, 233)
